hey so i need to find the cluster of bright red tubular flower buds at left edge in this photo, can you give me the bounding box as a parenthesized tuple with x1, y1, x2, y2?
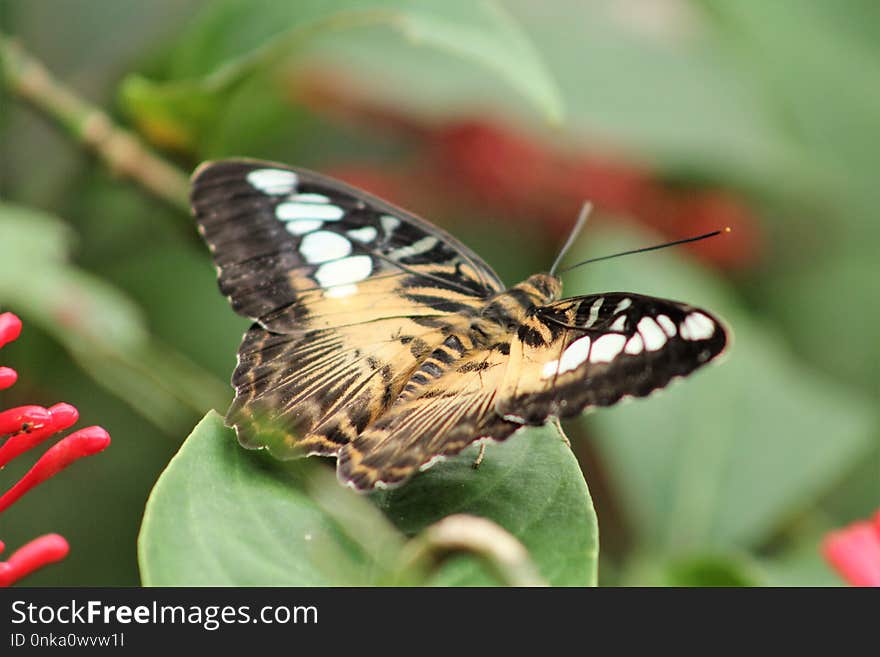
(0, 313, 110, 586)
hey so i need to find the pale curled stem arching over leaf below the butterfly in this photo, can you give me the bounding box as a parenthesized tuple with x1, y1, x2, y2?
(401, 513, 547, 586)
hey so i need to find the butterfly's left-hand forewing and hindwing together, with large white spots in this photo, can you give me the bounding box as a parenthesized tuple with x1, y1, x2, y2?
(191, 160, 503, 458)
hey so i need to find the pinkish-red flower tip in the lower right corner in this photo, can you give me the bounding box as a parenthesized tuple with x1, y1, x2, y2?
(822, 511, 880, 587)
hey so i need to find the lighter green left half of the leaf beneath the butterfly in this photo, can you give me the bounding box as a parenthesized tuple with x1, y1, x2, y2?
(138, 412, 388, 586)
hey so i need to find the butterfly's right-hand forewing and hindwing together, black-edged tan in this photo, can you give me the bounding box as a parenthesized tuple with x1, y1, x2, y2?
(339, 293, 727, 489)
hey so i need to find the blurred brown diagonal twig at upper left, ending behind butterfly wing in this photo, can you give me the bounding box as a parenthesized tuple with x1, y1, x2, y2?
(0, 32, 189, 212)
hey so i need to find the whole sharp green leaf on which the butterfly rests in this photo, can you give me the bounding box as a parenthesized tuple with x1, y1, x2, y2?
(138, 413, 598, 586)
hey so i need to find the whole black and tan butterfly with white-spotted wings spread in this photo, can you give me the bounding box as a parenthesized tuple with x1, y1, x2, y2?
(191, 160, 727, 491)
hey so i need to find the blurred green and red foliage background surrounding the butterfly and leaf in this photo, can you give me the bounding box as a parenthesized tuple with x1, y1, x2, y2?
(0, 0, 880, 585)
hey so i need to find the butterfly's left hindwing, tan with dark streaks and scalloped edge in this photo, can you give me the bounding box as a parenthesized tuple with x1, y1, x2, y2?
(227, 317, 464, 458)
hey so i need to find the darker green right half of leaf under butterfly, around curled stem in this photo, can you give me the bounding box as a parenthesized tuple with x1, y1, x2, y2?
(379, 426, 599, 586)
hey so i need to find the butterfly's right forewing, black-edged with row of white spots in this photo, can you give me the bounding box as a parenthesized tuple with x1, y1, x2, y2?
(495, 292, 728, 424)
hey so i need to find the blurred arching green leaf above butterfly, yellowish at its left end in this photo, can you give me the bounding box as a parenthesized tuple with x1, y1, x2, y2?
(121, 0, 562, 149)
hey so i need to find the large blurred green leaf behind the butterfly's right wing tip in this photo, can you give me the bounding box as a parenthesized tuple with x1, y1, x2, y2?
(575, 226, 876, 554)
